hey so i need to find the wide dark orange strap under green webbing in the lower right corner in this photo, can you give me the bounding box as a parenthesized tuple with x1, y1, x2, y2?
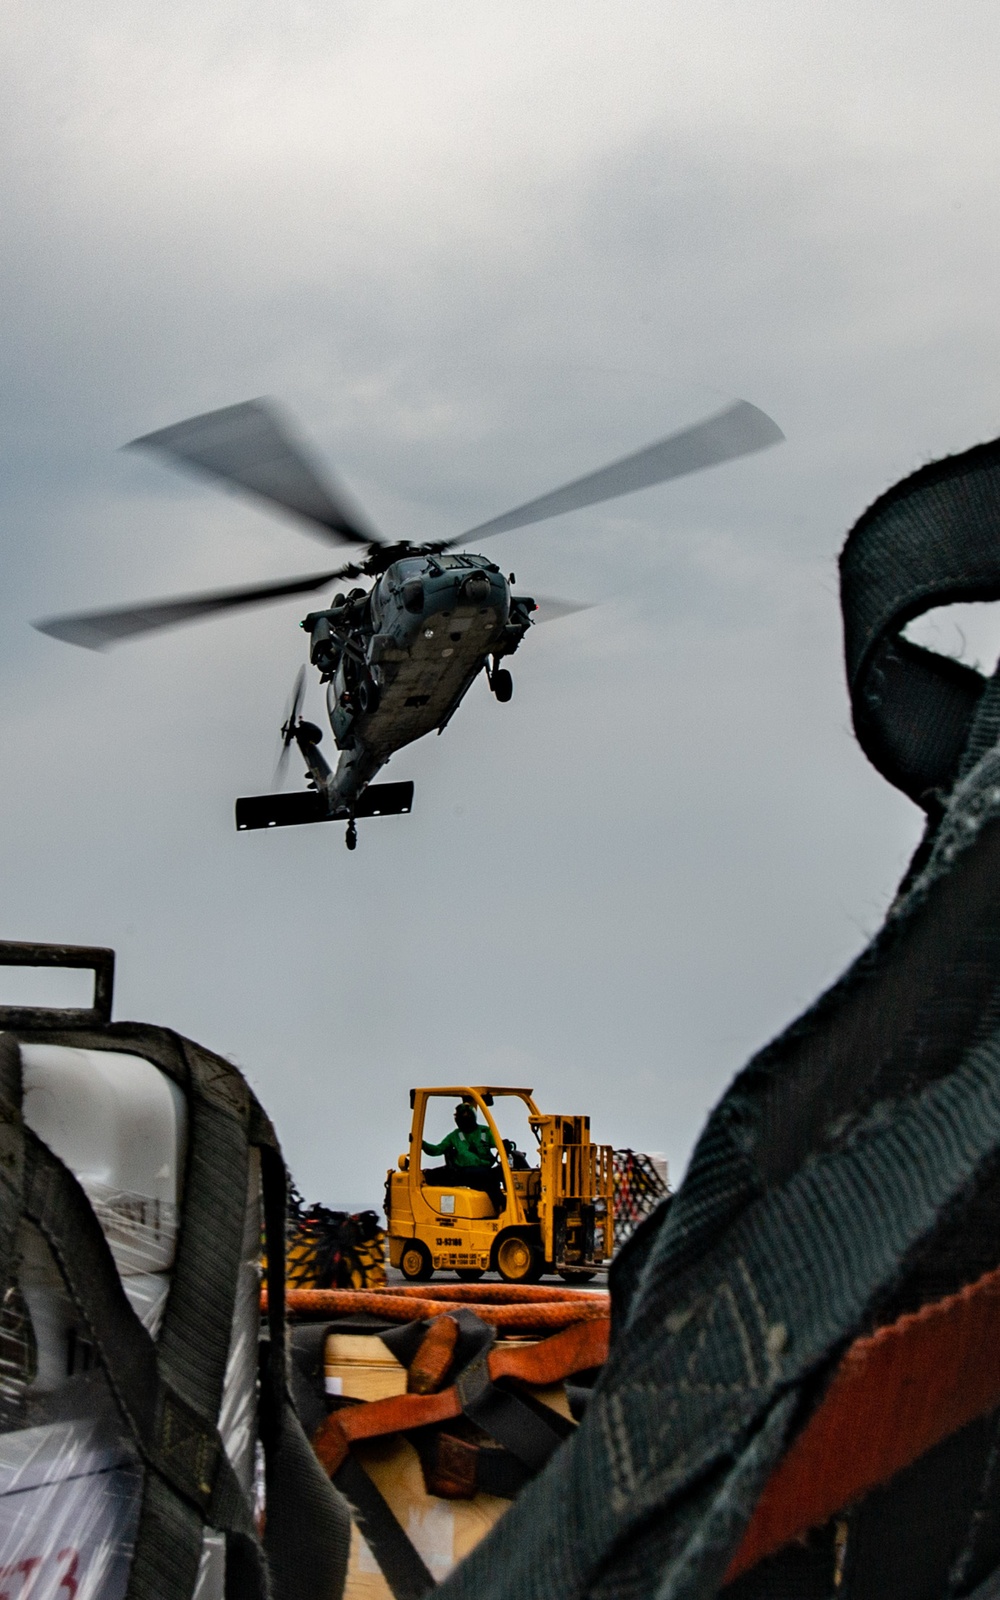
(726, 1267, 1000, 1582)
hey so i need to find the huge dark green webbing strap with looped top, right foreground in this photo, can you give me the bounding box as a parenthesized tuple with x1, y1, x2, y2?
(438, 443, 1000, 1600)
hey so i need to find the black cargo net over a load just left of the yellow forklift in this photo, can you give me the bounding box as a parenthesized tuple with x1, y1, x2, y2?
(285, 1184, 386, 1290)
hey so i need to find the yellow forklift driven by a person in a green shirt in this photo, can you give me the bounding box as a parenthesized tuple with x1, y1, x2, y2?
(386, 1085, 614, 1283)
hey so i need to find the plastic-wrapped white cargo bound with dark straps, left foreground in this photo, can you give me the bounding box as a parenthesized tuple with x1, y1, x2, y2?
(0, 944, 349, 1600)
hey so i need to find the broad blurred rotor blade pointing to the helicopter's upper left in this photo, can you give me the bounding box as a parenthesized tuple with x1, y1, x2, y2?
(126, 400, 381, 544)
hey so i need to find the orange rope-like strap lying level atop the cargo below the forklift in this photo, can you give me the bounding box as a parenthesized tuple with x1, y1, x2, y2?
(275, 1283, 608, 1333)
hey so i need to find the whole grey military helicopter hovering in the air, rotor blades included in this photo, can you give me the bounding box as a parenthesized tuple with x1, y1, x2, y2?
(34, 400, 784, 850)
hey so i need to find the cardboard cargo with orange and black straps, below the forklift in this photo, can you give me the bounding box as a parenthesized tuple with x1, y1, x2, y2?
(281, 1285, 610, 1600)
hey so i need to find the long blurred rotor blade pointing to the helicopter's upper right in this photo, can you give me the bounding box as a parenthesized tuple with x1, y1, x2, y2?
(450, 400, 784, 546)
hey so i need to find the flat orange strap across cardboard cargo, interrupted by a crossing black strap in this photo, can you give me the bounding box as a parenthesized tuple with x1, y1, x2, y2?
(312, 1318, 611, 1477)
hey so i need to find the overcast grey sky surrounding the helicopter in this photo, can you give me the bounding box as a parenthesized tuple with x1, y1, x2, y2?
(0, 0, 1000, 1202)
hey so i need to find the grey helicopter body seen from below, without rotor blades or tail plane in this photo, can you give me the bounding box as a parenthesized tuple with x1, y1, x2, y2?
(296, 555, 534, 816)
